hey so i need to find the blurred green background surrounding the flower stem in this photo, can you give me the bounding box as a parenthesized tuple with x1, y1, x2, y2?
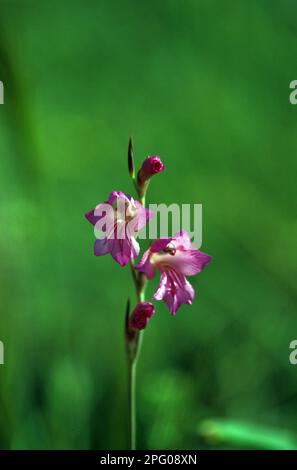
(0, 0, 297, 449)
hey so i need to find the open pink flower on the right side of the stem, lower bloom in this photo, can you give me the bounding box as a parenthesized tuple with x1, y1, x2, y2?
(136, 230, 211, 315)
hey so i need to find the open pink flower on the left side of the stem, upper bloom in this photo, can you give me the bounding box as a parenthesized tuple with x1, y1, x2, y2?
(85, 191, 153, 266)
